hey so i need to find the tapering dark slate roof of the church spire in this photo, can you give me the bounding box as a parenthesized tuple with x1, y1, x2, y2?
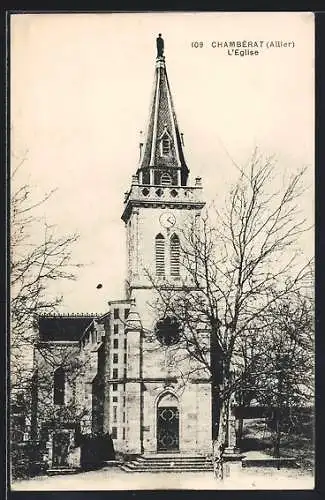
(139, 37, 188, 182)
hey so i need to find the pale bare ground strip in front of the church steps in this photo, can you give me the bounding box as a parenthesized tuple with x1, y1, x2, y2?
(11, 467, 314, 491)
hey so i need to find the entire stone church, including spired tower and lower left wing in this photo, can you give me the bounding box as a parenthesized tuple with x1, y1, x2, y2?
(32, 35, 212, 467)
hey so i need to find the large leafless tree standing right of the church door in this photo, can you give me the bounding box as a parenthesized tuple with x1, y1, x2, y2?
(149, 151, 311, 475)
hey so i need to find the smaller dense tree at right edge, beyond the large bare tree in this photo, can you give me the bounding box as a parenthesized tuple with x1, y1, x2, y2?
(244, 293, 314, 457)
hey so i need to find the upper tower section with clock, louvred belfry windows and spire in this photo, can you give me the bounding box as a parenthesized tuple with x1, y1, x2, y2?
(122, 35, 205, 318)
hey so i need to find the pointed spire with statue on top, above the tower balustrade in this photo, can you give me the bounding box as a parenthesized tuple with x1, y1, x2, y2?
(137, 34, 189, 186)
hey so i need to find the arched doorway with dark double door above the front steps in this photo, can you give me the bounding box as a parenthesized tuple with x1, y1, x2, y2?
(157, 392, 179, 452)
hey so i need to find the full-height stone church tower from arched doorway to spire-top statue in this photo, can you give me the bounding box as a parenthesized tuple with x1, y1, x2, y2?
(116, 35, 211, 454)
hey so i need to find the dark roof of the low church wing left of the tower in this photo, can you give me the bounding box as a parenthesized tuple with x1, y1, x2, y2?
(38, 314, 99, 342)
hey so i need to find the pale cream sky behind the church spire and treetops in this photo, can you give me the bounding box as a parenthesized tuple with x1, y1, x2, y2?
(10, 12, 314, 313)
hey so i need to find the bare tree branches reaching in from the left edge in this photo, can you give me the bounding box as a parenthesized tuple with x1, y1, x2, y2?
(10, 154, 80, 391)
